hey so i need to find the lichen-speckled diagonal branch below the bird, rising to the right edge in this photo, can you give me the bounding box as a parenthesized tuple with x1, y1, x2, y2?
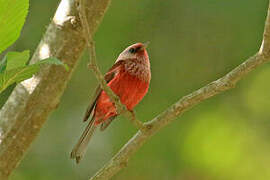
(90, 1, 270, 180)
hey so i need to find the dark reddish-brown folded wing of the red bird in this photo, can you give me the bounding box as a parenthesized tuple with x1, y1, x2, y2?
(83, 60, 125, 121)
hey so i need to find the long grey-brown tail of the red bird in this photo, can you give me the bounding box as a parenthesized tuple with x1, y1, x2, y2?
(70, 118, 97, 164)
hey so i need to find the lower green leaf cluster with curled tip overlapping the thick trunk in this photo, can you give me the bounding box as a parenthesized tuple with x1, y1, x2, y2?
(0, 54, 68, 93)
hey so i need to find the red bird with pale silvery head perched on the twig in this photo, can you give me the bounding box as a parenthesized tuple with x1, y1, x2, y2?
(71, 43, 151, 163)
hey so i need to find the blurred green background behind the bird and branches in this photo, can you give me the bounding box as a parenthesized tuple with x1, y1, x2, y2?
(7, 0, 270, 180)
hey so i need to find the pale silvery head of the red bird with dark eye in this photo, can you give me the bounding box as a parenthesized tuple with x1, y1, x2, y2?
(116, 42, 149, 61)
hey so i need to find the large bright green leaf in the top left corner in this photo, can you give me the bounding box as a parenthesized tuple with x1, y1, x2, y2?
(0, 0, 29, 53)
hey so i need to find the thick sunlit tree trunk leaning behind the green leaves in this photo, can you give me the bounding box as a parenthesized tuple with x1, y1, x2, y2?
(0, 0, 110, 179)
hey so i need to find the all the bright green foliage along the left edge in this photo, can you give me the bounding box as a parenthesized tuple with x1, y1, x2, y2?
(0, 0, 67, 107)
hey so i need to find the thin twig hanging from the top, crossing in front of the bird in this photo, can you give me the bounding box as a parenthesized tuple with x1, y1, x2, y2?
(79, 0, 143, 129)
